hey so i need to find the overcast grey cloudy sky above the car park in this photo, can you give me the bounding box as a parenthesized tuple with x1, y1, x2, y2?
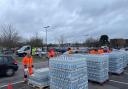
(0, 0, 128, 42)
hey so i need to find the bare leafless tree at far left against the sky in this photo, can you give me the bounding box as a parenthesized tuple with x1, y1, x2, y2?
(0, 24, 21, 48)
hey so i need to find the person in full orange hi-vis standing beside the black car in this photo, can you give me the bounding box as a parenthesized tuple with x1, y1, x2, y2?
(22, 51, 34, 81)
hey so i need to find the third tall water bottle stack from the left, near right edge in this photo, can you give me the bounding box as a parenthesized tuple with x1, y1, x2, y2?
(109, 52, 124, 74)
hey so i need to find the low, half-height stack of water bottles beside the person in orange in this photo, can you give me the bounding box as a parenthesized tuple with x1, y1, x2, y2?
(28, 68, 50, 87)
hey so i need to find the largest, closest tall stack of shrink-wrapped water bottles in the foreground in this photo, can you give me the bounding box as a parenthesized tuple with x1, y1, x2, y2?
(49, 55, 88, 89)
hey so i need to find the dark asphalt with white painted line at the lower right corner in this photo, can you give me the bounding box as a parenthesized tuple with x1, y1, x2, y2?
(89, 68, 128, 89)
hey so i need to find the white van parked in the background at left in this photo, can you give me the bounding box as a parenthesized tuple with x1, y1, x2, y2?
(17, 45, 31, 57)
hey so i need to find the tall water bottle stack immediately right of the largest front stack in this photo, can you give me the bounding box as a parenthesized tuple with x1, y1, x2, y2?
(85, 54, 109, 84)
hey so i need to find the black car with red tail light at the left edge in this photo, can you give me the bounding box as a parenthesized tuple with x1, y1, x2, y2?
(0, 56, 18, 76)
